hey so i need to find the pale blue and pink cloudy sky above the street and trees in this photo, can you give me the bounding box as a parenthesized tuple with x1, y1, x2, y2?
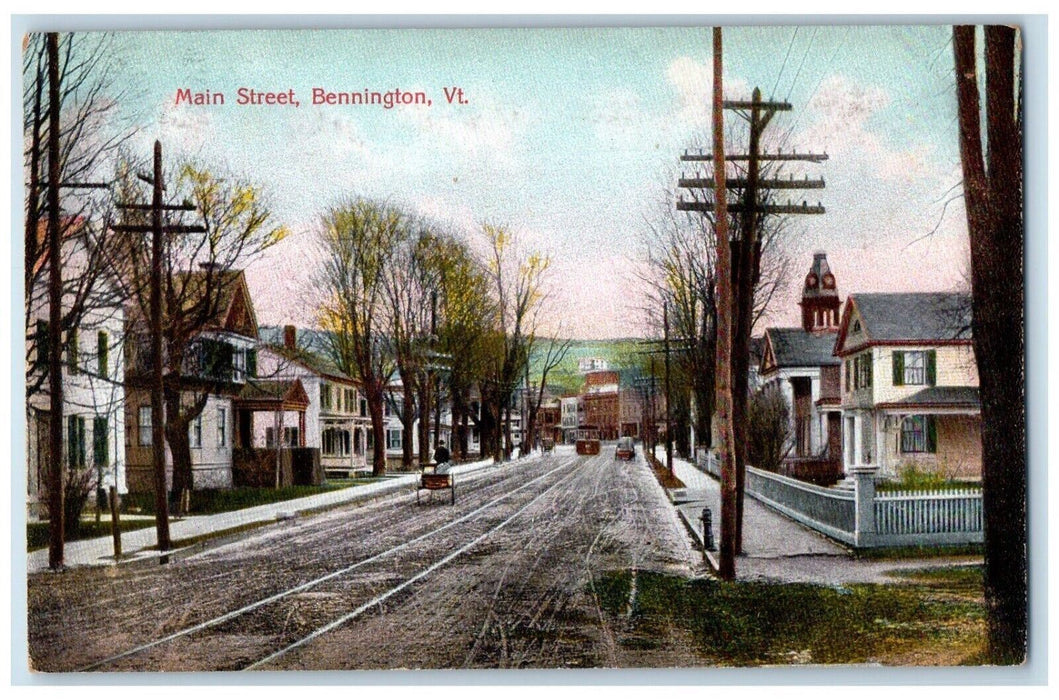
(91, 25, 968, 338)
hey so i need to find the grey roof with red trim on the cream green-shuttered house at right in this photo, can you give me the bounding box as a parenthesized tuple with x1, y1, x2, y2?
(834, 292, 971, 353)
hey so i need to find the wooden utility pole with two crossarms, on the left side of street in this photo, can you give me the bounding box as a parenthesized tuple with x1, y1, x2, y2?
(113, 141, 203, 562)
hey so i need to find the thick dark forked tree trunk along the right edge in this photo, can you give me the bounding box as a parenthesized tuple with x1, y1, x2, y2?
(953, 25, 1027, 664)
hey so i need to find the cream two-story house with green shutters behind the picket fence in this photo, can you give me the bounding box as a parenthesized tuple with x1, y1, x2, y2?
(834, 292, 982, 479)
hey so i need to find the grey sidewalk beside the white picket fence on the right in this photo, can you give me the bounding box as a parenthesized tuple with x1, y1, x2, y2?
(660, 455, 982, 586)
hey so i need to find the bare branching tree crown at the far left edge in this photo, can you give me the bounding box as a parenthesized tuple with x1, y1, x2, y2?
(22, 34, 134, 399)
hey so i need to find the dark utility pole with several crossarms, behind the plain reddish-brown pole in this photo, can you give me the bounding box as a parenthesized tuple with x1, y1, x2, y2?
(677, 45, 828, 558)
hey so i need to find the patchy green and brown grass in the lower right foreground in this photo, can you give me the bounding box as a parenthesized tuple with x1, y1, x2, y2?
(593, 568, 986, 666)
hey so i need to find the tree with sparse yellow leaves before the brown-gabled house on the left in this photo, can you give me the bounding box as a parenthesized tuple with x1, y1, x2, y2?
(116, 159, 287, 507)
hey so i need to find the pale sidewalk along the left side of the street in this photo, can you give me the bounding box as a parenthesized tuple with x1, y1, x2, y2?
(26, 460, 492, 574)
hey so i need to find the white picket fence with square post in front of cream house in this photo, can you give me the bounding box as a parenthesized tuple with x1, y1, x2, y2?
(699, 453, 983, 548)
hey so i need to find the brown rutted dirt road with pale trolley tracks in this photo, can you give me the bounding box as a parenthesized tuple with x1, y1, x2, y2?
(29, 448, 702, 670)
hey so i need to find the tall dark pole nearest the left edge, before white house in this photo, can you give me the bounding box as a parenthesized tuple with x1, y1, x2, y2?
(48, 32, 65, 570)
